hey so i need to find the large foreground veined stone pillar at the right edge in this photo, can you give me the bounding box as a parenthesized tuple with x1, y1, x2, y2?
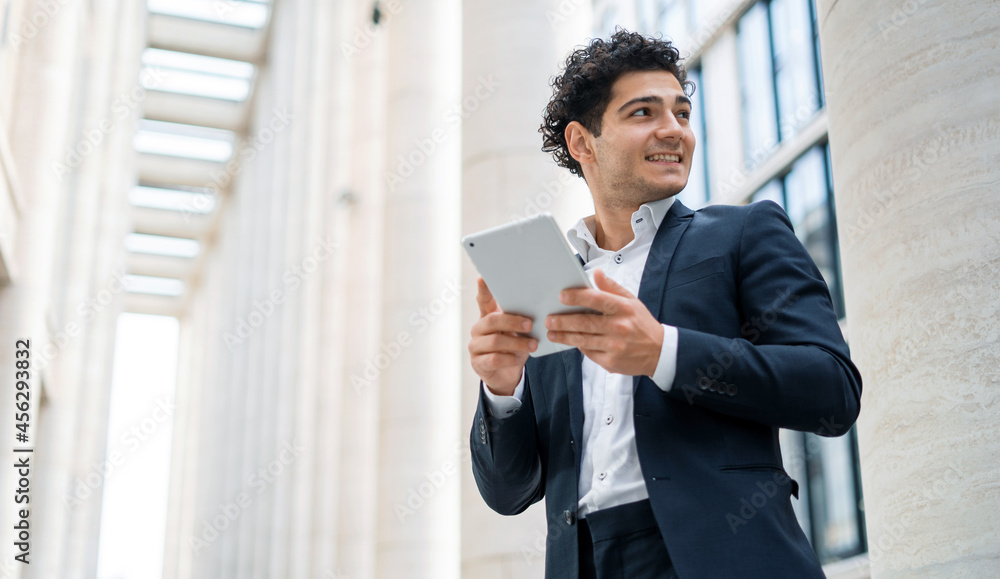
(819, 0, 1000, 579)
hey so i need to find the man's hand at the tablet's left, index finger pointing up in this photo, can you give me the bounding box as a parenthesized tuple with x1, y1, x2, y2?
(469, 278, 538, 396)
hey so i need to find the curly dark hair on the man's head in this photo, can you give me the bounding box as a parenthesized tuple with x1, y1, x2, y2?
(538, 28, 695, 177)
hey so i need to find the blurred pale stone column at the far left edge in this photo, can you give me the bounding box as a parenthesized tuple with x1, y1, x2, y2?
(0, 2, 86, 577)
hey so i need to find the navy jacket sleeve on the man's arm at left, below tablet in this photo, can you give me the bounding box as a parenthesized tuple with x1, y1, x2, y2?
(469, 378, 545, 515)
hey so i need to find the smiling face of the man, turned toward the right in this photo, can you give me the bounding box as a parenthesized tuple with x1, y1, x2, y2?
(588, 71, 695, 209)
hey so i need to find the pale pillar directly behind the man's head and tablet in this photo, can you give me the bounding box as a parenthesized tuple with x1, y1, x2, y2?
(461, 0, 593, 579)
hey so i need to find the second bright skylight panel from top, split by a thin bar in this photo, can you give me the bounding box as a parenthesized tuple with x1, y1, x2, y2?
(140, 48, 254, 102)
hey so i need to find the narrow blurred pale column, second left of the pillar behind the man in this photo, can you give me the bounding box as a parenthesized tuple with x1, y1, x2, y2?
(301, 0, 356, 577)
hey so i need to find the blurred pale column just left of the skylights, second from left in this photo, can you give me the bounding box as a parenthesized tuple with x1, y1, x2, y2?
(60, 1, 146, 578)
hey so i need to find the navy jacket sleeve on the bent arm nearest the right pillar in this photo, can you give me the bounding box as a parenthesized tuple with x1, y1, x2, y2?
(668, 202, 861, 436)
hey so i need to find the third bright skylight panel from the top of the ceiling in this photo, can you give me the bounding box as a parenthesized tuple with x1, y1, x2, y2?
(134, 119, 236, 163)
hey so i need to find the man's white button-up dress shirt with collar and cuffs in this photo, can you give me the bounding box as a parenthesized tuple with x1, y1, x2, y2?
(484, 197, 677, 517)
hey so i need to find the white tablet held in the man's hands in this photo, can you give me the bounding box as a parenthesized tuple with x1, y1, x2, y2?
(462, 213, 594, 356)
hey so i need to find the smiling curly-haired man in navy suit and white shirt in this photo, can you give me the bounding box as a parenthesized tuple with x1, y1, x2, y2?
(469, 31, 861, 579)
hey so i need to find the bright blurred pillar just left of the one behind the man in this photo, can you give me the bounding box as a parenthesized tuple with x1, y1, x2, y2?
(373, 0, 462, 579)
